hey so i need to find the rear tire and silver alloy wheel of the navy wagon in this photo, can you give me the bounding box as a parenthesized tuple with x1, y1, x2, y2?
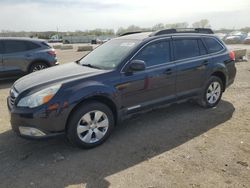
(198, 76, 223, 108)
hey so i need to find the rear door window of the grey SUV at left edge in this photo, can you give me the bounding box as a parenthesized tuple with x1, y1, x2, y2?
(4, 40, 27, 53)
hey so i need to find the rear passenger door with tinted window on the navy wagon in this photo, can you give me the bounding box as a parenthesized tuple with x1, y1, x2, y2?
(173, 37, 209, 99)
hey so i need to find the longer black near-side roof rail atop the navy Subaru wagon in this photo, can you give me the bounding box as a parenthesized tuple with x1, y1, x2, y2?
(150, 28, 214, 36)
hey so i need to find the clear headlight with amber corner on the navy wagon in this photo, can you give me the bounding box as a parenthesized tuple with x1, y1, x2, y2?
(17, 84, 61, 108)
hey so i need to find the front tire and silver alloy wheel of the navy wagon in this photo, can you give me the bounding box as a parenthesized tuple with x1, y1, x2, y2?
(66, 101, 114, 149)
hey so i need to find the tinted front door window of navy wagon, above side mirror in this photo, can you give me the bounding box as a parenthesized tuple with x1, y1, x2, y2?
(134, 41, 170, 67)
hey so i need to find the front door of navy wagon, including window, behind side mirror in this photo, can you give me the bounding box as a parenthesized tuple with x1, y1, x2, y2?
(121, 39, 176, 111)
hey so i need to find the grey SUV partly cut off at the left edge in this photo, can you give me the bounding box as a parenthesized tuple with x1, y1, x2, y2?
(0, 38, 58, 80)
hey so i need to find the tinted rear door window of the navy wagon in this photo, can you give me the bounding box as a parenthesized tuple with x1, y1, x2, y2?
(174, 39, 200, 60)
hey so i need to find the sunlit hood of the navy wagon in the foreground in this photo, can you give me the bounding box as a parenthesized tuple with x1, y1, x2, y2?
(14, 63, 106, 93)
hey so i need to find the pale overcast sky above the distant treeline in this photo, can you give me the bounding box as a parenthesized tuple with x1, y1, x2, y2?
(0, 0, 250, 31)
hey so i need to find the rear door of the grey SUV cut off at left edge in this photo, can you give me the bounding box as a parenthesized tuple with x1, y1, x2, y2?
(3, 40, 28, 74)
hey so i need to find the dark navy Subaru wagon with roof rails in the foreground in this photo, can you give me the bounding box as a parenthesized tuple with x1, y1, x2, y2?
(8, 29, 236, 148)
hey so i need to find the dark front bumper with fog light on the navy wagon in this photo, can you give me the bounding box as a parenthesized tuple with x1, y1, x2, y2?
(7, 97, 69, 138)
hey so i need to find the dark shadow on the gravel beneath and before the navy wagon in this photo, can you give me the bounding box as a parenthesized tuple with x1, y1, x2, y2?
(0, 101, 235, 188)
